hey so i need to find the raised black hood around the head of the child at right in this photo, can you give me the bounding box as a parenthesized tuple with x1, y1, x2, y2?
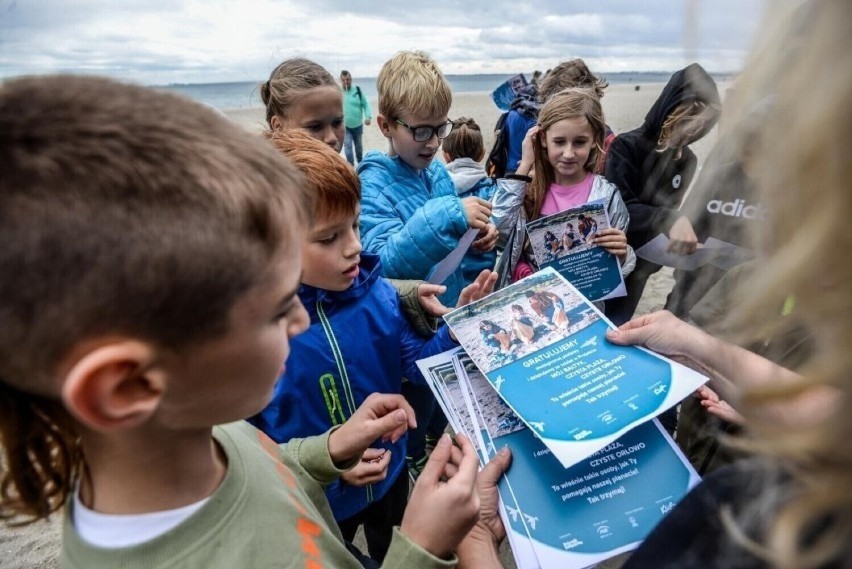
(642, 63, 720, 140)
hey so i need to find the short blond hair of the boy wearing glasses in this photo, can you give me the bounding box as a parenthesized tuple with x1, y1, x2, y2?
(376, 51, 453, 120)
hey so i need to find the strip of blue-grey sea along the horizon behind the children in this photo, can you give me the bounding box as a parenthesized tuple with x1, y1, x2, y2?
(156, 71, 732, 110)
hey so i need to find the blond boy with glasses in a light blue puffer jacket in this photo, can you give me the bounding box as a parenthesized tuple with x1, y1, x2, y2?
(358, 52, 497, 476)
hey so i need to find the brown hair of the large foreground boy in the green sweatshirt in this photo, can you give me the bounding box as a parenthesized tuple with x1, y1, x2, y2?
(0, 76, 312, 521)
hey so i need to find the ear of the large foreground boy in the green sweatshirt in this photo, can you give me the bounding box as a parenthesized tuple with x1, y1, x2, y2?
(62, 340, 166, 431)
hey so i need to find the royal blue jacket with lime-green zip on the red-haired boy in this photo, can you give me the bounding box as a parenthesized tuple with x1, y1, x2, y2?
(250, 254, 458, 520)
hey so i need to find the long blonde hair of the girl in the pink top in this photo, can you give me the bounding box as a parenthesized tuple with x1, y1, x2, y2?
(524, 89, 606, 221)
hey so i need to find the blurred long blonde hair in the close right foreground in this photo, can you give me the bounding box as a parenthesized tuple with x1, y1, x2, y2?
(726, 0, 852, 569)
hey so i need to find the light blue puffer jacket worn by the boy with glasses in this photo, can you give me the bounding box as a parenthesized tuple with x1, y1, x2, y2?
(358, 151, 468, 306)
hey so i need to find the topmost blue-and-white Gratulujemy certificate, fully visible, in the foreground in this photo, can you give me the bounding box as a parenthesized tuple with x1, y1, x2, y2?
(444, 268, 707, 468)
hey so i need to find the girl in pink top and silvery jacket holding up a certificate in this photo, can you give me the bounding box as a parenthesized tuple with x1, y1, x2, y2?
(492, 89, 636, 292)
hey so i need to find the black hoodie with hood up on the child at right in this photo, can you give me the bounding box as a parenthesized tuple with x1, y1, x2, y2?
(606, 63, 719, 249)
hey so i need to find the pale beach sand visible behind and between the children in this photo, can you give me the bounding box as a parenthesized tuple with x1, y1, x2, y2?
(0, 80, 725, 569)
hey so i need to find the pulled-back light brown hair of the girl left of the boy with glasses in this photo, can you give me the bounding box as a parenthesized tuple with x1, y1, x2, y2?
(260, 57, 337, 129)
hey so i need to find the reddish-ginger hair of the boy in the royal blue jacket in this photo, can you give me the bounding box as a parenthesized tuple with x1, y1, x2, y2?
(270, 129, 361, 220)
